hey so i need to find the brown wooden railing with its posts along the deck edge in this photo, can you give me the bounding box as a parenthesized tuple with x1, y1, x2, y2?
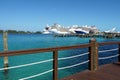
(0, 38, 120, 80)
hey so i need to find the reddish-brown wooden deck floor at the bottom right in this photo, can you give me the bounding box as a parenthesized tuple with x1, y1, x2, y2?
(61, 63, 120, 80)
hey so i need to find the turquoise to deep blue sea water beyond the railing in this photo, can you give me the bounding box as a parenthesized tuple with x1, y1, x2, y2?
(0, 34, 120, 80)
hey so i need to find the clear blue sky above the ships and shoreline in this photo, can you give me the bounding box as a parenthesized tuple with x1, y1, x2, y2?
(0, 0, 120, 31)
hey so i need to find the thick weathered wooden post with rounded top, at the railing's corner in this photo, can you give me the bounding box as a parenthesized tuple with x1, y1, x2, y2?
(89, 38, 98, 71)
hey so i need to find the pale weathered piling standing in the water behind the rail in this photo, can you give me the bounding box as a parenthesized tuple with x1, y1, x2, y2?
(3, 31, 8, 70)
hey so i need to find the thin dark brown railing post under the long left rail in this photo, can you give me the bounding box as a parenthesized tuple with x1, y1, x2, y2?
(53, 50, 58, 80)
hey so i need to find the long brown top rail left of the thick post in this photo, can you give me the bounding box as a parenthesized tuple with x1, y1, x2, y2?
(0, 44, 90, 56)
